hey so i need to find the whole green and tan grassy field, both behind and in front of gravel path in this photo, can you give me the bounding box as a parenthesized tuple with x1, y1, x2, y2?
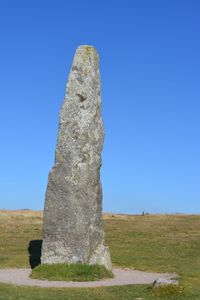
(0, 211, 200, 300)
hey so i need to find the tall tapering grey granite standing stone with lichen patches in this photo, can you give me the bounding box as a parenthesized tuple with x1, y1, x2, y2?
(41, 46, 112, 269)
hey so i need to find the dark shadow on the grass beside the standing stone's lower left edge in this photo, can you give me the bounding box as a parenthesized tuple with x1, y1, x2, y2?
(28, 240, 42, 269)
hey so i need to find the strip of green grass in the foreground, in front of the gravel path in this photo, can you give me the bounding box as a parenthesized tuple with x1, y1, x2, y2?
(0, 284, 200, 300)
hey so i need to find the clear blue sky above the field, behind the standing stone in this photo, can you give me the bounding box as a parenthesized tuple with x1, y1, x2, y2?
(0, 0, 200, 213)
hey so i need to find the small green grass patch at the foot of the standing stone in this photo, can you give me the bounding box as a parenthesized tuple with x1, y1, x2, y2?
(31, 264, 113, 281)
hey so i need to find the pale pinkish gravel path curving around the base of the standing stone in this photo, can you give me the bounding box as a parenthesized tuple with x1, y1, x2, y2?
(0, 269, 175, 287)
